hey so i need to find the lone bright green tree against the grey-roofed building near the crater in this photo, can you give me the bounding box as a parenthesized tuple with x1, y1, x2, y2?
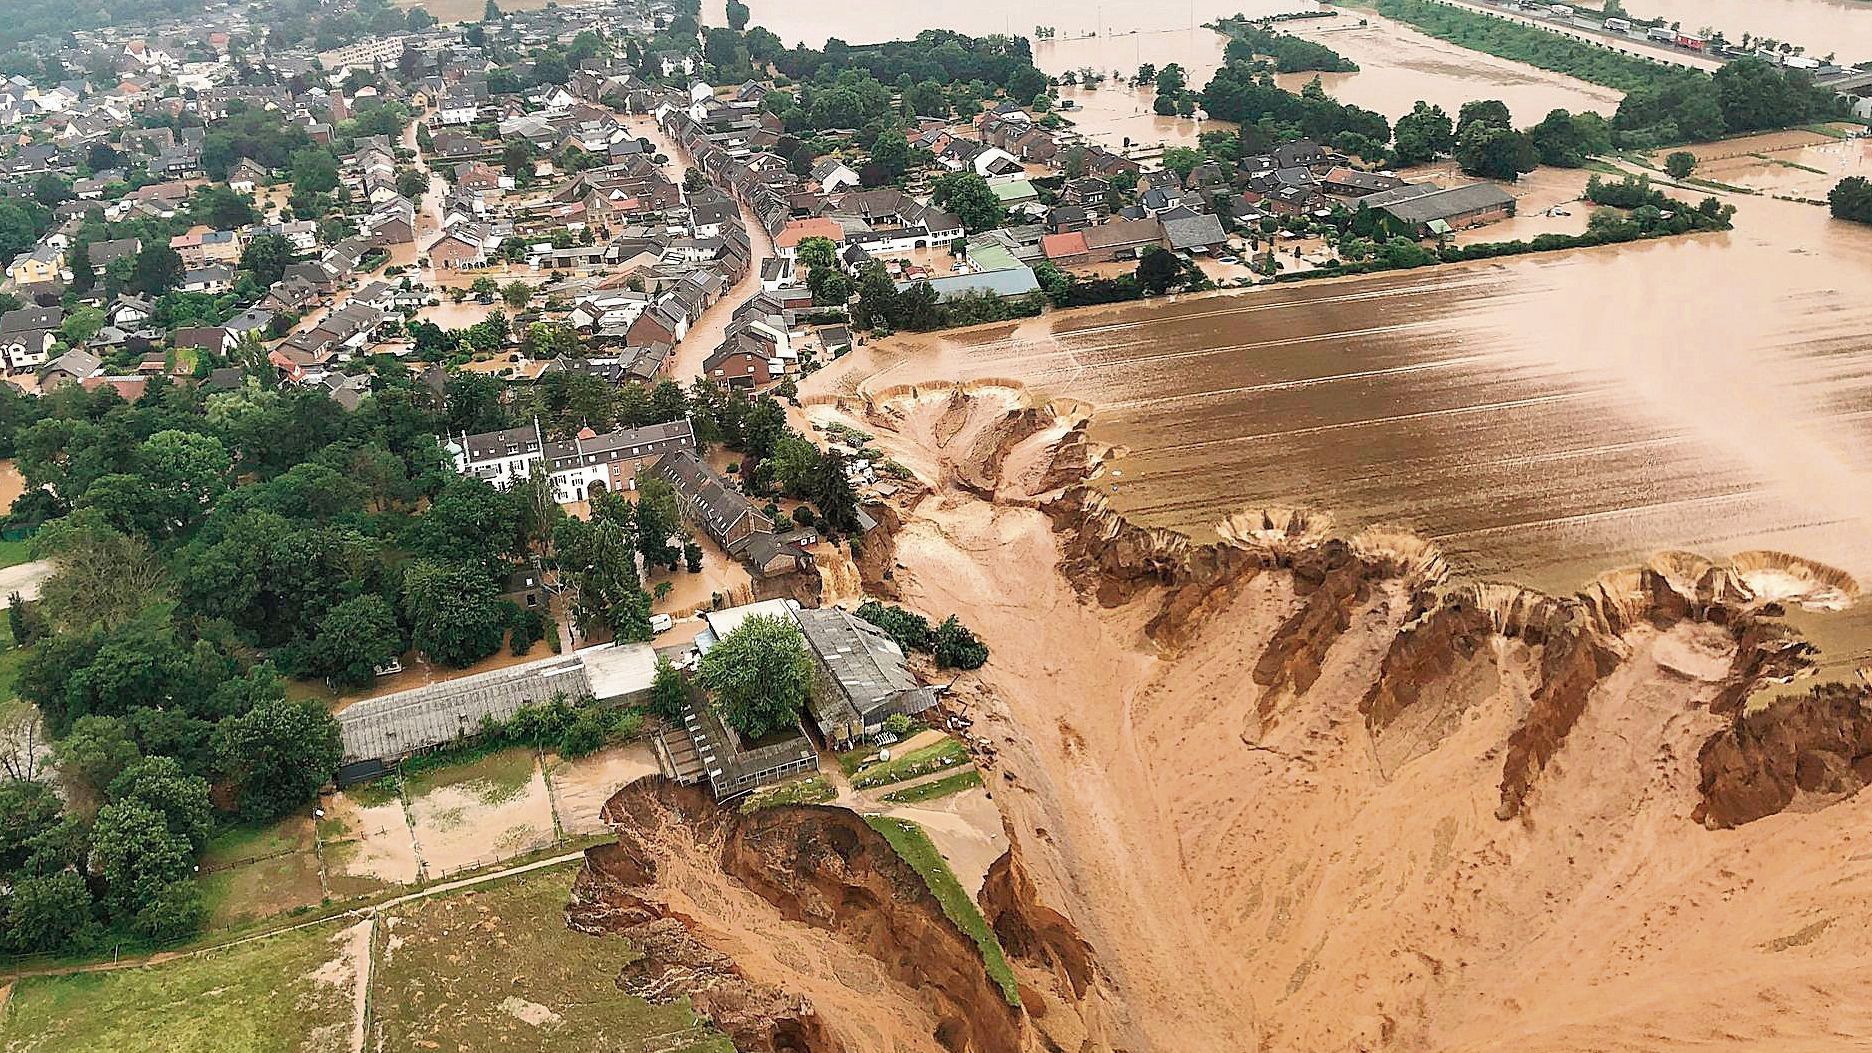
(696, 615, 812, 738)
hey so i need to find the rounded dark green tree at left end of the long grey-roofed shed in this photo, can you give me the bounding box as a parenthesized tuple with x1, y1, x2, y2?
(215, 697, 343, 823)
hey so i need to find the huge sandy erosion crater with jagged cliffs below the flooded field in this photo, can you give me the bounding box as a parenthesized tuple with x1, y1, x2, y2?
(814, 382, 1872, 1051)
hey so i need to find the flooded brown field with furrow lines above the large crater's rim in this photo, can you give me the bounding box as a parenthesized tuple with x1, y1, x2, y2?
(819, 186, 1872, 607)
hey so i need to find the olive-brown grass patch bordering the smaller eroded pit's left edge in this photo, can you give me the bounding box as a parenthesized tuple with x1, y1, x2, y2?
(373, 868, 734, 1053)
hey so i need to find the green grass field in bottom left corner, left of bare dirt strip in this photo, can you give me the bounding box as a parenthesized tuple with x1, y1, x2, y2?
(0, 922, 354, 1053)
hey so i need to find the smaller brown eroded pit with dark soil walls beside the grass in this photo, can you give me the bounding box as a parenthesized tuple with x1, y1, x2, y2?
(569, 778, 1028, 1053)
